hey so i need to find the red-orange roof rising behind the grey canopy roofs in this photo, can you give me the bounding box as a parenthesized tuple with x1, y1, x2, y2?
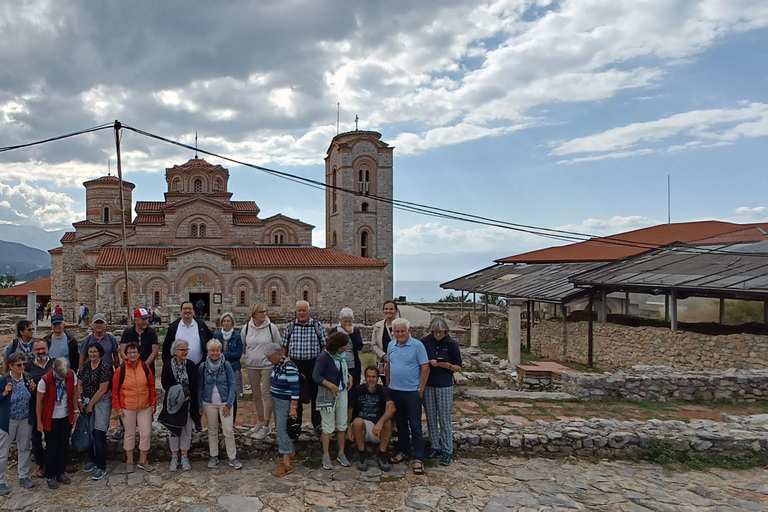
(496, 220, 753, 263)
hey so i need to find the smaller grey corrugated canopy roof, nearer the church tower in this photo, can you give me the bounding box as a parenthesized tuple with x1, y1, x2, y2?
(440, 262, 604, 304)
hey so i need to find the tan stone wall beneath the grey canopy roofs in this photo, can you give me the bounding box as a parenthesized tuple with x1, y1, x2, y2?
(531, 320, 768, 370)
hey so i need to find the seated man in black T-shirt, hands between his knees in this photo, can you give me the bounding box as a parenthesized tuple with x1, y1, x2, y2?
(347, 365, 395, 471)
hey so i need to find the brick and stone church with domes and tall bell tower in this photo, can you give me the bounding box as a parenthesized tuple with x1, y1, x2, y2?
(49, 131, 393, 321)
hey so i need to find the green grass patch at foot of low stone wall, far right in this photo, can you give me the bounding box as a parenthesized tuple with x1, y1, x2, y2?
(640, 439, 768, 471)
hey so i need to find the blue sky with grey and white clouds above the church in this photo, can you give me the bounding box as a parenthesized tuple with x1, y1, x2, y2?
(0, 0, 768, 296)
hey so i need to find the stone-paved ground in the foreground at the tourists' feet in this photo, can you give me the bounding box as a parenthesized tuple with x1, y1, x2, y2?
(0, 458, 768, 512)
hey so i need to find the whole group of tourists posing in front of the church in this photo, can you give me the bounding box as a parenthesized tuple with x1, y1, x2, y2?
(0, 301, 461, 495)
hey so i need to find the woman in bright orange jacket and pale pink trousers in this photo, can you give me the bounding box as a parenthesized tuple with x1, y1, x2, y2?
(112, 342, 157, 473)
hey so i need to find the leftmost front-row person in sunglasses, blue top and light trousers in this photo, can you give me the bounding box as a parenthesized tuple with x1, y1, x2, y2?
(0, 352, 36, 495)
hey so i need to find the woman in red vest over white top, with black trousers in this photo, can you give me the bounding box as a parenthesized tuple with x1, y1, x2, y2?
(37, 357, 80, 489)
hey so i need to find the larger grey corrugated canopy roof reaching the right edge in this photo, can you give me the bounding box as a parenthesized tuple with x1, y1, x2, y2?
(571, 241, 768, 300)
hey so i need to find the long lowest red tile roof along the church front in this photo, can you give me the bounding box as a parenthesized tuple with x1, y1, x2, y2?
(96, 245, 387, 268)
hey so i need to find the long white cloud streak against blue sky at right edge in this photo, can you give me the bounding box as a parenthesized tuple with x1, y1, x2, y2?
(550, 103, 768, 159)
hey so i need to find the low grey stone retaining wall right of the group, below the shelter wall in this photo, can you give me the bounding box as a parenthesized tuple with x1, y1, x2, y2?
(562, 366, 768, 402)
